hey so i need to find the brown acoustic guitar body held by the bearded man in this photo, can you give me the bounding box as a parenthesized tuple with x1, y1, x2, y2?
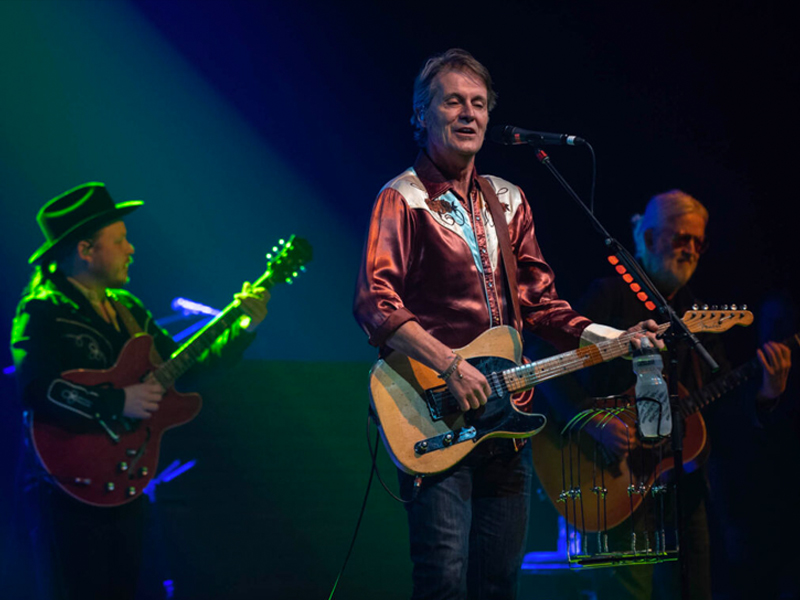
(531, 400, 707, 532)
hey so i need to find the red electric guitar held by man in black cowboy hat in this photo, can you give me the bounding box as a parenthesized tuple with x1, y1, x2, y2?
(30, 236, 312, 506)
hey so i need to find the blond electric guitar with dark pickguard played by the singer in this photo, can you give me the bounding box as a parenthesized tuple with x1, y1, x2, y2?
(369, 310, 753, 475)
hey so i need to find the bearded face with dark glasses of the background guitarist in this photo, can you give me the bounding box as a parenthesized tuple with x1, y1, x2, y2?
(642, 213, 706, 296)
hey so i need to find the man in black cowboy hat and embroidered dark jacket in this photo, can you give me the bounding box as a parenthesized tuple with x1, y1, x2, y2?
(11, 183, 269, 600)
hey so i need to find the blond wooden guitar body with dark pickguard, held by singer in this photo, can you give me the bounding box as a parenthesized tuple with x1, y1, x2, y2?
(369, 327, 546, 475)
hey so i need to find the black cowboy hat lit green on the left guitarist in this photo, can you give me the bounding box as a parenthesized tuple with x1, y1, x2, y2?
(28, 181, 144, 263)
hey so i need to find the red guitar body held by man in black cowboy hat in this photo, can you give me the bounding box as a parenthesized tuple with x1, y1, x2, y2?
(31, 334, 202, 507)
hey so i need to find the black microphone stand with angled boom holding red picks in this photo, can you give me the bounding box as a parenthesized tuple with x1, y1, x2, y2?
(531, 142, 719, 600)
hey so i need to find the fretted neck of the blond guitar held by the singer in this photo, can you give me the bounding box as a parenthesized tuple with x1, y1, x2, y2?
(501, 323, 669, 393)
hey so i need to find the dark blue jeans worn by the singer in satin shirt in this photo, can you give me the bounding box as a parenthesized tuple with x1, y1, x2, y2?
(400, 440, 533, 600)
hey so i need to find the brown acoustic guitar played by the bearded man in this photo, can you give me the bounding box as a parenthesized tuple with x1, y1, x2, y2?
(532, 333, 800, 532)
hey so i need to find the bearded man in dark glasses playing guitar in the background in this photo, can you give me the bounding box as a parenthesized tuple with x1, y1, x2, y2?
(564, 190, 791, 600)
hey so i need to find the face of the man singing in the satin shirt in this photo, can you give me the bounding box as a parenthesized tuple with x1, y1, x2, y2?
(418, 71, 489, 160)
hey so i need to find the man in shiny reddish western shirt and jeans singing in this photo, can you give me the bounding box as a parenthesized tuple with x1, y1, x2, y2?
(354, 49, 660, 600)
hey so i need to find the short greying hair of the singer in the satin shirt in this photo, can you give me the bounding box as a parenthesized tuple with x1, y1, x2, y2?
(411, 48, 497, 146)
